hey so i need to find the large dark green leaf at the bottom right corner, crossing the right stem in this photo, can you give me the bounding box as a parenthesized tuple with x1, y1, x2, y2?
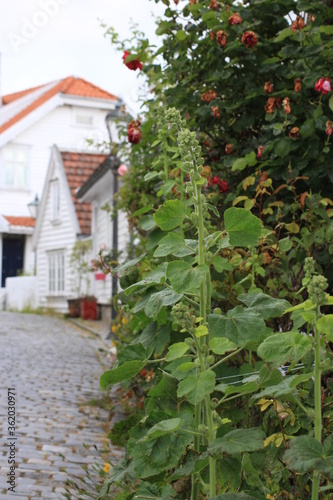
(284, 435, 333, 479)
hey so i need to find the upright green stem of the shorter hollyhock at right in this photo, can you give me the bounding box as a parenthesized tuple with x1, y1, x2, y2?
(311, 306, 322, 500)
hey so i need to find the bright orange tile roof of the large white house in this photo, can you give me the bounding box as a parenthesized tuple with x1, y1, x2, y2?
(0, 76, 118, 134)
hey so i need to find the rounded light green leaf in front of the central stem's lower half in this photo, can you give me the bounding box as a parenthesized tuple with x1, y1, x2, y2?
(177, 370, 216, 405)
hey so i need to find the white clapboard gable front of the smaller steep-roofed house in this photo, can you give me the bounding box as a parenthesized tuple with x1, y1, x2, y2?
(37, 157, 76, 312)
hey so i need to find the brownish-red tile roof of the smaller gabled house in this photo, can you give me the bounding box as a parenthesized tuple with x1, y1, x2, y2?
(60, 152, 108, 235)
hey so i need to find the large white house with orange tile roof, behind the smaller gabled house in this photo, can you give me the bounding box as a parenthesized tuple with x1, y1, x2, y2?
(0, 76, 119, 292)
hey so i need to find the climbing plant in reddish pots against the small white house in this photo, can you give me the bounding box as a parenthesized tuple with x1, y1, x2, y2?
(68, 240, 97, 319)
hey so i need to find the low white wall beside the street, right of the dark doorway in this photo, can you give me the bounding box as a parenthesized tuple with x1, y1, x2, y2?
(6, 276, 38, 311)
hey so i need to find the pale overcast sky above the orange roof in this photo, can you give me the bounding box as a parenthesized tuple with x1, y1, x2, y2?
(0, 0, 165, 111)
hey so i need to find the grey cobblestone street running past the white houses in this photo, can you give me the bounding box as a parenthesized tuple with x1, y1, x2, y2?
(0, 312, 122, 500)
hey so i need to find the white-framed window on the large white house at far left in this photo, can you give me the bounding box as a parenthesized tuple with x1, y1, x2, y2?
(3, 145, 29, 188)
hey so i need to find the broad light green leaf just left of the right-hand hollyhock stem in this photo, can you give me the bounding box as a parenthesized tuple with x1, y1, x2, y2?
(257, 331, 312, 367)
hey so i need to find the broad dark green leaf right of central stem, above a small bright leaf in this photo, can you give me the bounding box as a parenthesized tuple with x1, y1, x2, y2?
(209, 306, 266, 347)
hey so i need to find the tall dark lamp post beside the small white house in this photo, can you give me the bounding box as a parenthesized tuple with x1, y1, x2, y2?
(105, 104, 122, 340)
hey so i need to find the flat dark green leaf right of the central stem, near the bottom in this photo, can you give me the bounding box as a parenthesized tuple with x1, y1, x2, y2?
(209, 427, 266, 455)
